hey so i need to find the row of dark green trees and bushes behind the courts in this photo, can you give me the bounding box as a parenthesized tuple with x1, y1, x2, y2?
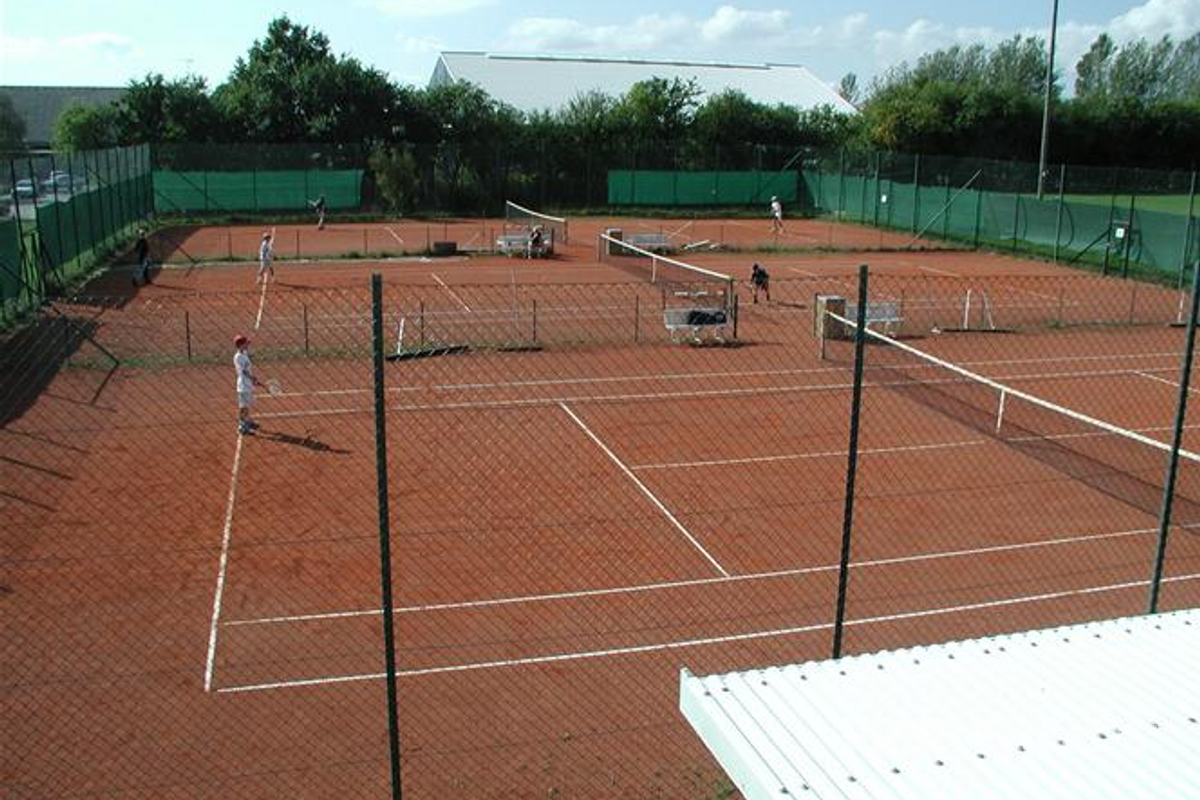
(9, 16, 1200, 191)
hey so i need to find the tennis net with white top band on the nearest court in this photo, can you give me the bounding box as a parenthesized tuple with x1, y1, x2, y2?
(822, 312, 1200, 525)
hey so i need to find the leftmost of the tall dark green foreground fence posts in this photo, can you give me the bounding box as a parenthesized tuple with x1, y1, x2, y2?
(371, 272, 401, 800)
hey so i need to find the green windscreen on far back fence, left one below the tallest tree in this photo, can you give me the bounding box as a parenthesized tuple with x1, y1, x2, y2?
(154, 169, 364, 213)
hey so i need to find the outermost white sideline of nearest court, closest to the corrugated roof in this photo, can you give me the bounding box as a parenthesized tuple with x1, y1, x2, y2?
(217, 575, 1200, 694)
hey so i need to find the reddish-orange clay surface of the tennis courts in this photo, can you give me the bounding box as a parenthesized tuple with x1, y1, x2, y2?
(0, 219, 1200, 798)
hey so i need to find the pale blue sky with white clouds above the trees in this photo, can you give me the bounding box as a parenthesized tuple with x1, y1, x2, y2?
(0, 0, 1200, 86)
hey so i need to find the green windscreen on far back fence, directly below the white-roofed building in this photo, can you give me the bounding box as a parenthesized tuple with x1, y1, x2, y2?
(608, 169, 799, 206)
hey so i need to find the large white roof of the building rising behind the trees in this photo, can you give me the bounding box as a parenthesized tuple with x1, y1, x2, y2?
(430, 52, 856, 114)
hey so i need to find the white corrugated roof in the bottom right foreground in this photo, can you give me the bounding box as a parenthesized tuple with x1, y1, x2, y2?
(679, 610, 1200, 800)
